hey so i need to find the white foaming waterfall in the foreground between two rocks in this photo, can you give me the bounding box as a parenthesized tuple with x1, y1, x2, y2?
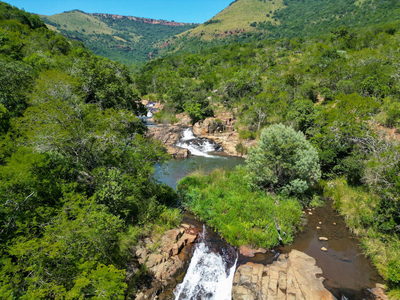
(174, 228, 237, 300)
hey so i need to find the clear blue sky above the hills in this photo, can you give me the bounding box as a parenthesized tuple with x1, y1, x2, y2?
(2, 0, 233, 23)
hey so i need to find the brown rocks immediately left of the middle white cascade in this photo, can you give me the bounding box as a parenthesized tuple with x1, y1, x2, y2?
(147, 125, 190, 158)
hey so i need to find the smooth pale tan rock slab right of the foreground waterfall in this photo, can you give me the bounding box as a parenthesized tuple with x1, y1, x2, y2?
(232, 250, 336, 300)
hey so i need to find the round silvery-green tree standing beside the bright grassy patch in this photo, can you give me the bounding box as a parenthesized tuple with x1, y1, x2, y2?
(246, 124, 321, 195)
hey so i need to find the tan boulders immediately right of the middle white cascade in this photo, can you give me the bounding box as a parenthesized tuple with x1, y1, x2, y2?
(193, 114, 257, 156)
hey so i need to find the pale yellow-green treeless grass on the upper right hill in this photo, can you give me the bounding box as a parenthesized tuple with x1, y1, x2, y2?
(181, 0, 284, 40)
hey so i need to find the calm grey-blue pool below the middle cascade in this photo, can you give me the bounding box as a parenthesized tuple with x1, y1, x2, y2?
(154, 152, 244, 189)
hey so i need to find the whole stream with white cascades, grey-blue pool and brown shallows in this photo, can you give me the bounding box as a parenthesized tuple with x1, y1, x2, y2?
(154, 129, 383, 300)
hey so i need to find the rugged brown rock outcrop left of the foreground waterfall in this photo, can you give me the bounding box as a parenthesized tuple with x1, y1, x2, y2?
(135, 226, 200, 300)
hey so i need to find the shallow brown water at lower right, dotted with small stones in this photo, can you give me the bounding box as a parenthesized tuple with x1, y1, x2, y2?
(279, 201, 382, 299)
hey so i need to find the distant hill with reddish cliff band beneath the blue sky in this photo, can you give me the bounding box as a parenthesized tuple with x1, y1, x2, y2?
(41, 10, 196, 64)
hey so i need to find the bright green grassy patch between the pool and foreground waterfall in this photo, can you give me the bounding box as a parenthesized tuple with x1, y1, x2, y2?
(178, 168, 302, 248)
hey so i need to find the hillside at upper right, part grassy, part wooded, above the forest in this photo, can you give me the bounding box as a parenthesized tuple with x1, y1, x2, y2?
(161, 0, 400, 55)
